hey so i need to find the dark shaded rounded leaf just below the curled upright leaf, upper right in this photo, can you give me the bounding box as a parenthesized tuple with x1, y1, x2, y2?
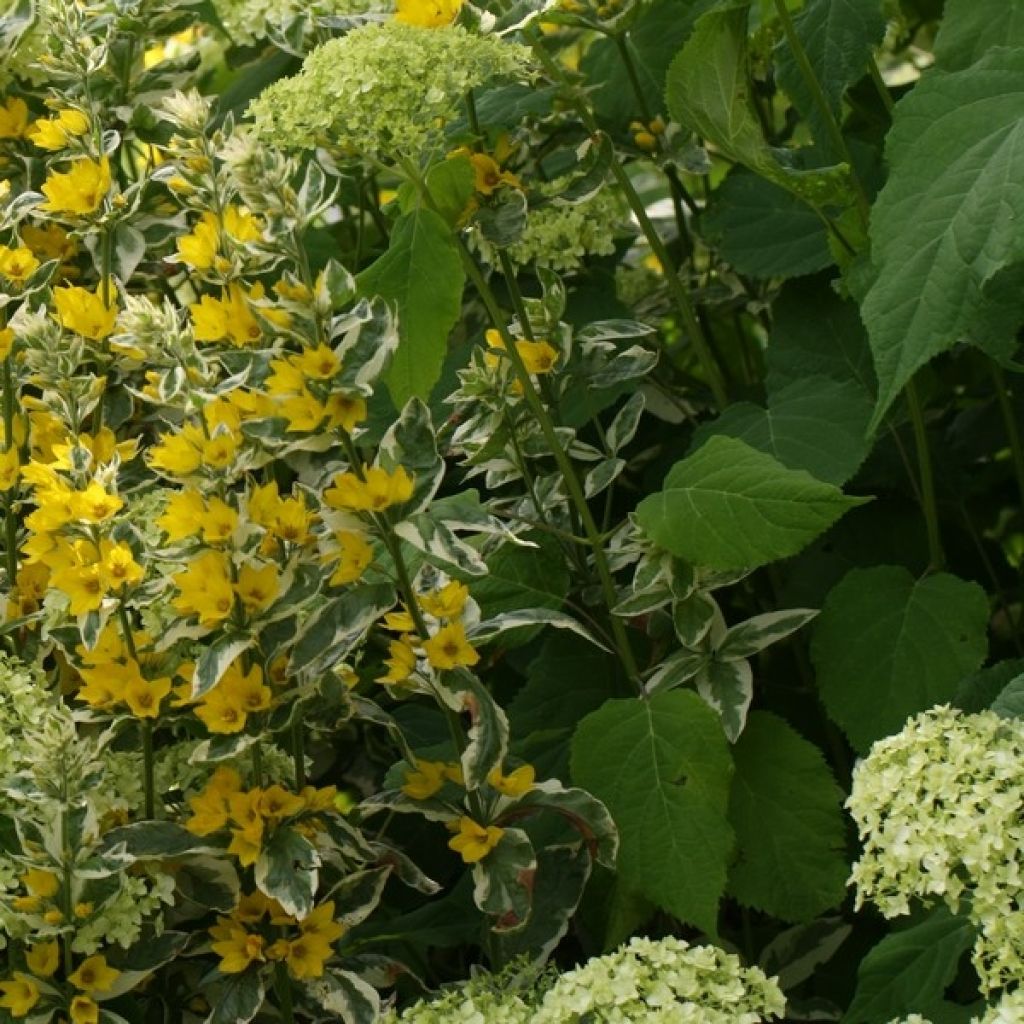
(699, 168, 833, 278)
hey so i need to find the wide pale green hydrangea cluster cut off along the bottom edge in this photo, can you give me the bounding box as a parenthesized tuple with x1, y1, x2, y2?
(384, 936, 785, 1024)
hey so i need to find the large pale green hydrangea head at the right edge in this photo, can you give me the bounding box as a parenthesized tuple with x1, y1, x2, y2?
(847, 707, 1024, 992)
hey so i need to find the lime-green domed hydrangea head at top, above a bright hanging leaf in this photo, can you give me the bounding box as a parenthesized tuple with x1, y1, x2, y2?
(250, 22, 529, 159)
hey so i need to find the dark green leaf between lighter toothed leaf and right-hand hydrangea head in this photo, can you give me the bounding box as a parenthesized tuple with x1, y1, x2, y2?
(729, 711, 850, 923)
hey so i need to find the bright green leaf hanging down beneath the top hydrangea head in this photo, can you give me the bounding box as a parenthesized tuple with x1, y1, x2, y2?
(356, 203, 465, 409)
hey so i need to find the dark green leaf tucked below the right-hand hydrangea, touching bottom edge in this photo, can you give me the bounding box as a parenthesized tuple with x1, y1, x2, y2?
(843, 906, 975, 1024)
